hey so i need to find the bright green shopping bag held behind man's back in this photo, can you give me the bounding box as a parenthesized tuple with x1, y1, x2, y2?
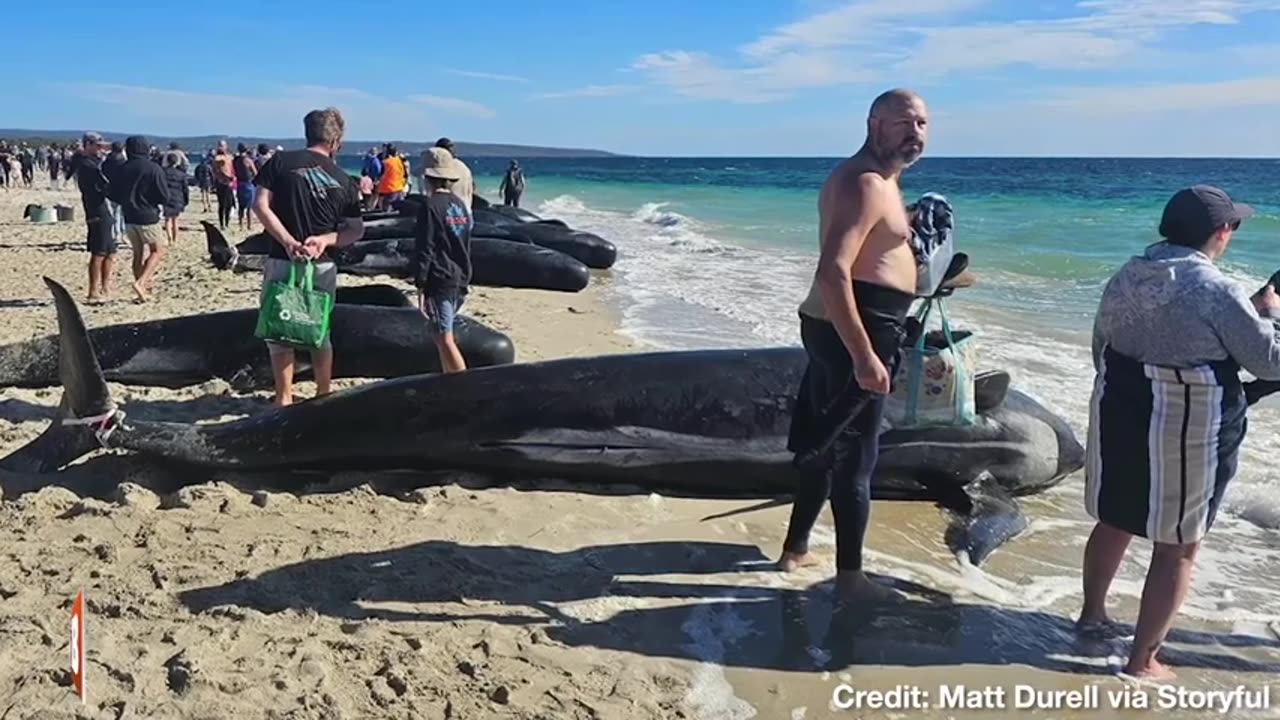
(253, 260, 333, 347)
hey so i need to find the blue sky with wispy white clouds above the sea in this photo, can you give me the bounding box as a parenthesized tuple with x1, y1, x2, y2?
(0, 0, 1280, 158)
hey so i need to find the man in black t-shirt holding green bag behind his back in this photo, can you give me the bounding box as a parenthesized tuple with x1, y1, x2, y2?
(253, 108, 365, 406)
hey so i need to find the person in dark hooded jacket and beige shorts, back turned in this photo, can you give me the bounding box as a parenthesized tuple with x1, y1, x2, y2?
(108, 135, 169, 302)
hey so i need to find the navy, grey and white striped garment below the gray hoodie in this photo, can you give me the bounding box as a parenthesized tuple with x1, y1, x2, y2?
(1084, 347, 1248, 544)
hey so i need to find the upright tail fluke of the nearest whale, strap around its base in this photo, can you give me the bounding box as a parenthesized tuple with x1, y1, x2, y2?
(0, 277, 118, 473)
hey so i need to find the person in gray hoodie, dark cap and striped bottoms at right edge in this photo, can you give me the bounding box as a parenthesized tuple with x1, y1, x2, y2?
(1076, 184, 1280, 679)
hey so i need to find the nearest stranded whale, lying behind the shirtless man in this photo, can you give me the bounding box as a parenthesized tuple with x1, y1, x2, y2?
(0, 278, 1084, 562)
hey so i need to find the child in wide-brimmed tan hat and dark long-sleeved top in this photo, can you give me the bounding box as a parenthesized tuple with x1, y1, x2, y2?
(412, 147, 472, 373)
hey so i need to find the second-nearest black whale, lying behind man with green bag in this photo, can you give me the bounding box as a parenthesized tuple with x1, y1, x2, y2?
(0, 286, 516, 389)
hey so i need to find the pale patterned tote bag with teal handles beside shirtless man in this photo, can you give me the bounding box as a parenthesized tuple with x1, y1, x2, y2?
(884, 299, 978, 428)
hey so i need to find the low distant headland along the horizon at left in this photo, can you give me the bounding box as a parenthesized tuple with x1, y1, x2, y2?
(0, 129, 623, 158)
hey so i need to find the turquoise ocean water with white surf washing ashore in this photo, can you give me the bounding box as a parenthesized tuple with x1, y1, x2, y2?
(352, 158, 1280, 696)
